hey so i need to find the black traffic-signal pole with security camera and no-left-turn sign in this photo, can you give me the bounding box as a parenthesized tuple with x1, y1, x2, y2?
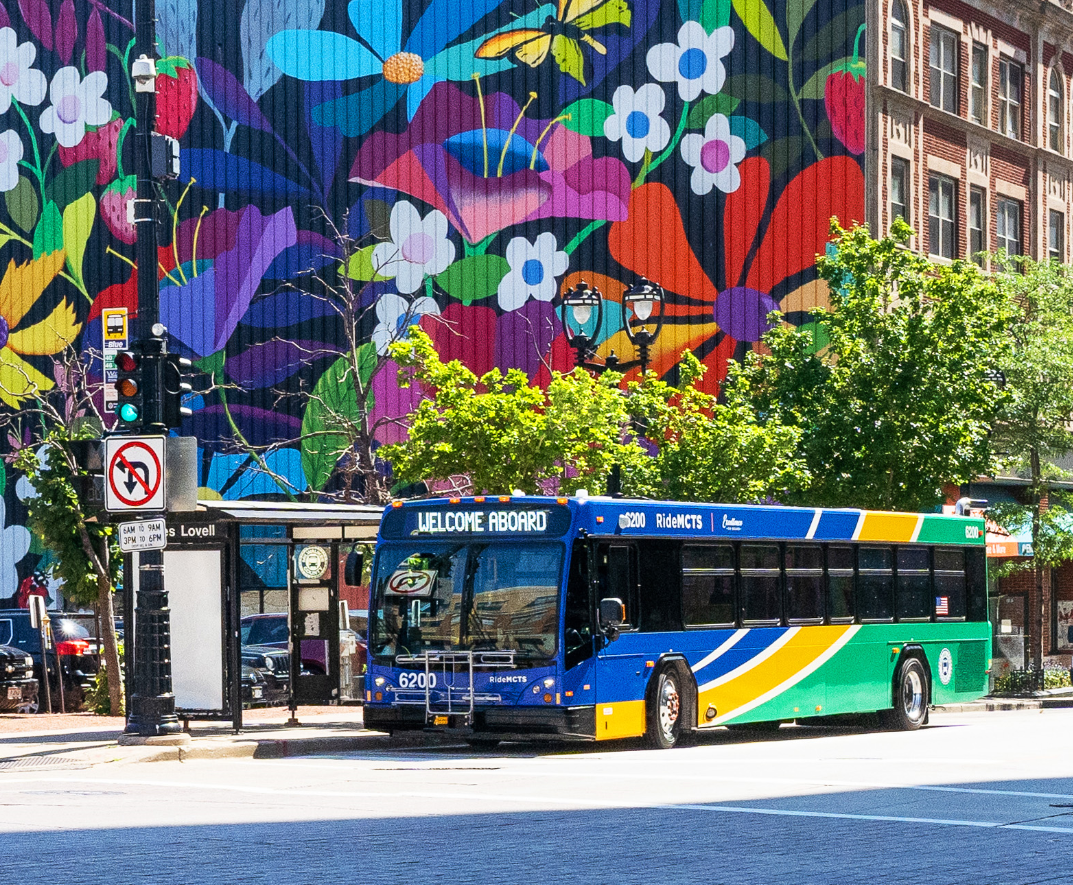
(122, 0, 189, 743)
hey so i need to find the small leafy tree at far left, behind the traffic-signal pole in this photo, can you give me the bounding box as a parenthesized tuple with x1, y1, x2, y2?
(0, 350, 123, 714)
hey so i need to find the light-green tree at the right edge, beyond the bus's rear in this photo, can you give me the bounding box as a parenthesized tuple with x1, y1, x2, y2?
(989, 255, 1073, 670)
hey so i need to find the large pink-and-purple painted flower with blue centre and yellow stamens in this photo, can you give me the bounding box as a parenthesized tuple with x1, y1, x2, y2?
(350, 83, 630, 242)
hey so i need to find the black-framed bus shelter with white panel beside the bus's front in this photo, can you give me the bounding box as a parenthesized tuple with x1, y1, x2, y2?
(124, 501, 383, 729)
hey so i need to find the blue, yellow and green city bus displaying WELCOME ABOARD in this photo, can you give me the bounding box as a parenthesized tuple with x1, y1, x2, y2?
(365, 492, 991, 749)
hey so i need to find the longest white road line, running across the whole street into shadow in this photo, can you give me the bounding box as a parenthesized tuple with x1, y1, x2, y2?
(3, 778, 1073, 836)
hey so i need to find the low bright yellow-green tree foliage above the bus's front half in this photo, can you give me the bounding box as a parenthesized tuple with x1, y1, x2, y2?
(379, 328, 807, 502)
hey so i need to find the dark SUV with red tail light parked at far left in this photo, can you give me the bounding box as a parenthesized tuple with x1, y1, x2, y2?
(0, 608, 98, 711)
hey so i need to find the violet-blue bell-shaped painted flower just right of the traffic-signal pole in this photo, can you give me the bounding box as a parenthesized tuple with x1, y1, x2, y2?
(160, 206, 298, 357)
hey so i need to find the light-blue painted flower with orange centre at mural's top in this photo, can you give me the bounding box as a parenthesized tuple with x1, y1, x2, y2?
(266, 0, 536, 137)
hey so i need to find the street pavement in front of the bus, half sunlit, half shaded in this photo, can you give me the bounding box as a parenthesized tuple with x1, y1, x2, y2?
(0, 710, 1073, 885)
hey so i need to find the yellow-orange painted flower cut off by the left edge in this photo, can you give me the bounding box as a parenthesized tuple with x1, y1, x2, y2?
(0, 250, 79, 409)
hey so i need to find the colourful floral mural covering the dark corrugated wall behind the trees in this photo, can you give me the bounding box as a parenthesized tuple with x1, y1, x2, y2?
(0, 0, 867, 599)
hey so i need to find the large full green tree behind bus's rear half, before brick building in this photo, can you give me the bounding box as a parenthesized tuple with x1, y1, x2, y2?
(732, 220, 1011, 511)
